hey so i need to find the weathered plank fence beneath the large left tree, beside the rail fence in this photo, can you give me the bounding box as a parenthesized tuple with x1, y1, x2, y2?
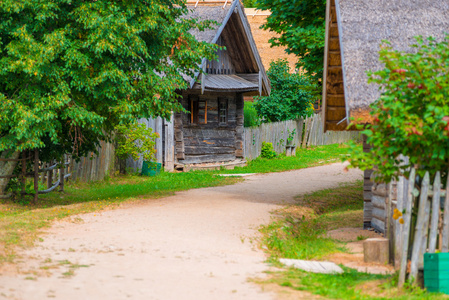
(69, 141, 115, 182)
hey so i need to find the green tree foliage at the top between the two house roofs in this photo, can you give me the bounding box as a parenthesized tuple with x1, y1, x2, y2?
(256, 0, 326, 80)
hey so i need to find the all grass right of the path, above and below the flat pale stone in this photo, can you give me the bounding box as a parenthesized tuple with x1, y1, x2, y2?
(258, 181, 448, 300)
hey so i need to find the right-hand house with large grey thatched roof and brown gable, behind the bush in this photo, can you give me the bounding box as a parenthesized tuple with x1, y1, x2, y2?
(323, 0, 449, 232)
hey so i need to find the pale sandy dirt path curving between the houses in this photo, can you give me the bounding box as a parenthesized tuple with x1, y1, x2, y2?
(0, 164, 362, 300)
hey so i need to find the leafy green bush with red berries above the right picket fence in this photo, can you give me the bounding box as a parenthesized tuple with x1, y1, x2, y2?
(350, 36, 449, 182)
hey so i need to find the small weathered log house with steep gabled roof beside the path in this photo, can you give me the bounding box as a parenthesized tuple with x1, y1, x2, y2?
(127, 0, 270, 171)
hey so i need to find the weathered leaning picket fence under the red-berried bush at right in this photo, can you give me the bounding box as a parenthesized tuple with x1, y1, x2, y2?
(386, 168, 449, 287)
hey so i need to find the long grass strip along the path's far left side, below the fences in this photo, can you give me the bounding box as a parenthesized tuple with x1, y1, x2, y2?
(0, 145, 354, 262)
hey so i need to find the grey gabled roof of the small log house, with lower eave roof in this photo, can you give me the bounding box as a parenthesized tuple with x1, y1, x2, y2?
(187, 0, 271, 95)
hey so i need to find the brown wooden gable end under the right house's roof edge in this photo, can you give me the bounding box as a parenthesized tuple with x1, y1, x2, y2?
(324, 0, 347, 130)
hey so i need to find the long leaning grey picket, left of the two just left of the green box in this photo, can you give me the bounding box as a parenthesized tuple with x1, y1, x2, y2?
(398, 168, 415, 288)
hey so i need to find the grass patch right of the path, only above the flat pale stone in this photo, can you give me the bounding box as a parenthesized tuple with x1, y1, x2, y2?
(261, 181, 363, 260)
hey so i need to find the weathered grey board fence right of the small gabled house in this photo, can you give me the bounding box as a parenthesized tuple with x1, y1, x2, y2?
(244, 114, 361, 160)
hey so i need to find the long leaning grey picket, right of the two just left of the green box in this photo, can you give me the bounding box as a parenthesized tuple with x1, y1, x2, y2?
(409, 172, 429, 285)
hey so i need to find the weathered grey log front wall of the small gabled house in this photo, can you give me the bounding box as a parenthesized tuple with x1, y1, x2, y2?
(174, 90, 243, 164)
